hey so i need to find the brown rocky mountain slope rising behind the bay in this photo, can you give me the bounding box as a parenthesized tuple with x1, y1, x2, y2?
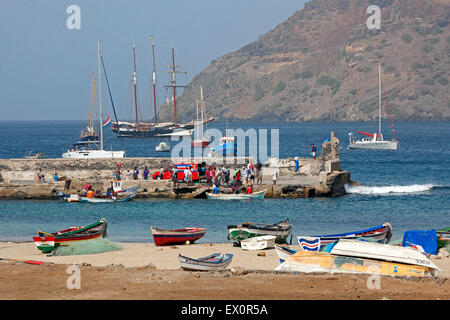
(160, 0, 450, 121)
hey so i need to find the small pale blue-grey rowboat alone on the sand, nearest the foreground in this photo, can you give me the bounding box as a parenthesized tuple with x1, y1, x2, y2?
(178, 253, 233, 271)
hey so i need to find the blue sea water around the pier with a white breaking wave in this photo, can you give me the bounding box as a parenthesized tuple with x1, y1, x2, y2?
(0, 121, 450, 243)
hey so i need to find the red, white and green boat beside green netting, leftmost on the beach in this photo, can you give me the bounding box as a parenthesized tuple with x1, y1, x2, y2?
(33, 218, 108, 253)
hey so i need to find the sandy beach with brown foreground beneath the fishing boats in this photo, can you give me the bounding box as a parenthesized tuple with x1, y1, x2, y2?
(0, 242, 450, 300)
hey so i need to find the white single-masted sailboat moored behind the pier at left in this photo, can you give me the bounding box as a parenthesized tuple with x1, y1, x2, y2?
(62, 41, 125, 159)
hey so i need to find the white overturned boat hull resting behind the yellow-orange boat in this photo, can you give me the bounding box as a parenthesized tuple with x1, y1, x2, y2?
(330, 240, 440, 270)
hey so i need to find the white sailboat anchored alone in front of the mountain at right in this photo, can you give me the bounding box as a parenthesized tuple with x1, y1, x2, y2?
(348, 64, 398, 150)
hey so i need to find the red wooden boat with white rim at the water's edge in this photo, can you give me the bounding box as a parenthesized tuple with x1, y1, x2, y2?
(150, 227, 206, 246)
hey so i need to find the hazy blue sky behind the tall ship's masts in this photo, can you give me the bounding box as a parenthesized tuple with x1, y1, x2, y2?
(0, 0, 306, 121)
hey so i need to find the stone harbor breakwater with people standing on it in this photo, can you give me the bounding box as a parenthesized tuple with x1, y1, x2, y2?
(0, 132, 352, 199)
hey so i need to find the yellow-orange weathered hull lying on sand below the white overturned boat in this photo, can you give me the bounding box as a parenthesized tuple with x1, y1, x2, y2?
(275, 251, 436, 277)
